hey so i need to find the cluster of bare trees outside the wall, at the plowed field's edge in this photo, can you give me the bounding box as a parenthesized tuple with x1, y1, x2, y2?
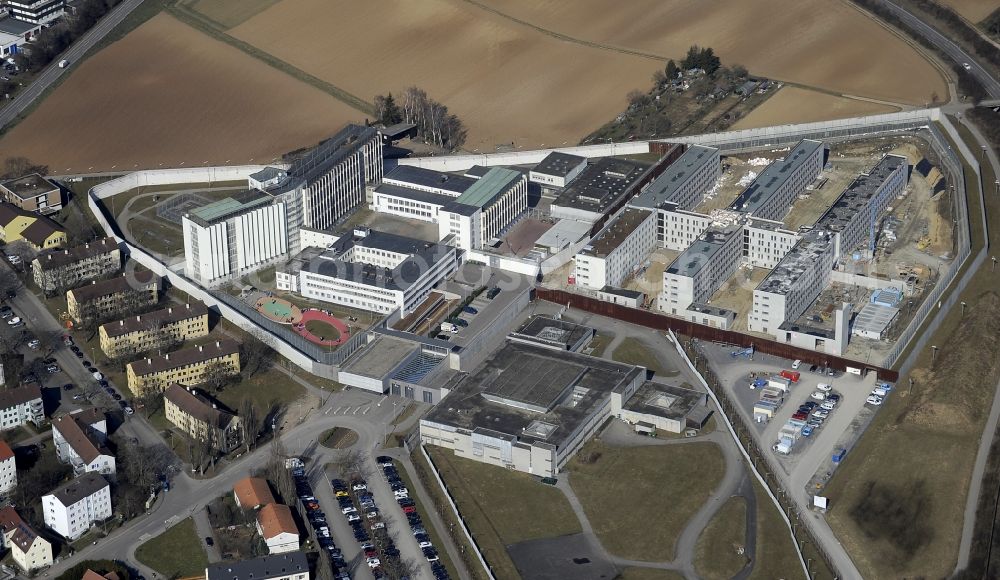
(375, 87, 468, 150)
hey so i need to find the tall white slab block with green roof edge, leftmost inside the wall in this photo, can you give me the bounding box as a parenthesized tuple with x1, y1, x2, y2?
(181, 190, 288, 286)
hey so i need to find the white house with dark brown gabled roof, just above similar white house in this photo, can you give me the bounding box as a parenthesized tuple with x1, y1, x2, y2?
(52, 409, 116, 476)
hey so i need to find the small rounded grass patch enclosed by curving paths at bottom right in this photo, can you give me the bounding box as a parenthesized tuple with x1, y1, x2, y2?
(694, 497, 747, 580)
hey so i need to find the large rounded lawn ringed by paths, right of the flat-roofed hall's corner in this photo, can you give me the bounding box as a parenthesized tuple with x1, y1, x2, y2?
(568, 439, 725, 562)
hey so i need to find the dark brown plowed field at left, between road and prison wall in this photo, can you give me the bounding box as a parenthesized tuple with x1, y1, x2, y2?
(0, 14, 364, 173)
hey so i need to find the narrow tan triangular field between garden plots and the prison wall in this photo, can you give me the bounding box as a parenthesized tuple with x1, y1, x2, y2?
(732, 86, 904, 129)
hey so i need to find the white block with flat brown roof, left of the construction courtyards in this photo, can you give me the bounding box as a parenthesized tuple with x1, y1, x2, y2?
(573, 207, 656, 290)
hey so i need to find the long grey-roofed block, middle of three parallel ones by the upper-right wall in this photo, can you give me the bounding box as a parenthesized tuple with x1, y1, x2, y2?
(729, 139, 826, 221)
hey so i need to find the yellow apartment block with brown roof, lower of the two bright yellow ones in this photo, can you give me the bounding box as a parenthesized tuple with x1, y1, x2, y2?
(125, 339, 240, 395)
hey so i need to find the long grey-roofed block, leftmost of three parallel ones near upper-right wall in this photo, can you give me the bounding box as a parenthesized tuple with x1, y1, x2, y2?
(629, 145, 722, 210)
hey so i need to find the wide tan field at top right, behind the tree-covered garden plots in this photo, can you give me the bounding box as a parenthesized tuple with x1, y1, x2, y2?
(468, 0, 944, 105)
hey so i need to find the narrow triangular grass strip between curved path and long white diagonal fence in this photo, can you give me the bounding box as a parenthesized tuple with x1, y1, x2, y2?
(750, 477, 804, 580)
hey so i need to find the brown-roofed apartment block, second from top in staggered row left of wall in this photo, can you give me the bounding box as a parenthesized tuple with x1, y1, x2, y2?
(66, 272, 160, 324)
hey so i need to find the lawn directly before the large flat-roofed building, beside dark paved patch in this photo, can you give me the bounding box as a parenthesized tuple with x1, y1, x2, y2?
(427, 447, 581, 578)
